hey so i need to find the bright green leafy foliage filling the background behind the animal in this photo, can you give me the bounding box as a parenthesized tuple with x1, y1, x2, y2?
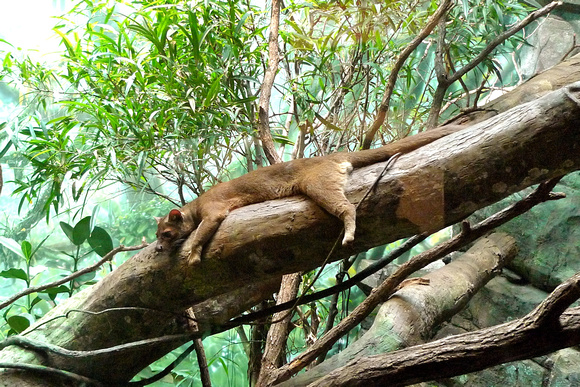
(0, 0, 530, 386)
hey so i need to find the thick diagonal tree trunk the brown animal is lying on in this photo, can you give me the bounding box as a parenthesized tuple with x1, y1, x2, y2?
(0, 79, 580, 386)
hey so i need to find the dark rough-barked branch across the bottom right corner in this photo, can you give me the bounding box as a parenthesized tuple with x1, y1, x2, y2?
(308, 273, 580, 387)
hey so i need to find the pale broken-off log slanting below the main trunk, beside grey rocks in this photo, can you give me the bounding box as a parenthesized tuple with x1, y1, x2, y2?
(280, 233, 517, 386)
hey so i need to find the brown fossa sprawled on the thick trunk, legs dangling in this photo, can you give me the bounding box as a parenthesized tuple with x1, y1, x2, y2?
(155, 125, 462, 264)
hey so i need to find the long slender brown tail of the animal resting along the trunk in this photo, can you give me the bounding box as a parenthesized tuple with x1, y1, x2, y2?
(348, 125, 465, 168)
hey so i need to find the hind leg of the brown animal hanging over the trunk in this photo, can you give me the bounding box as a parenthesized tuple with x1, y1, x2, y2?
(302, 164, 356, 245)
